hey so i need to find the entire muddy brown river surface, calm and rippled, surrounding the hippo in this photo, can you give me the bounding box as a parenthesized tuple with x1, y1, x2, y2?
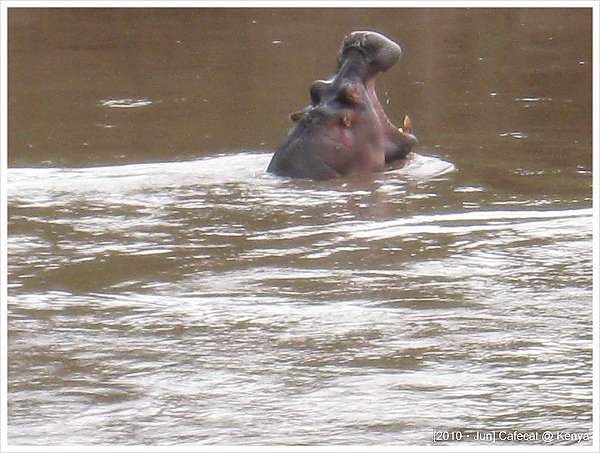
(7, 8, 593, 446)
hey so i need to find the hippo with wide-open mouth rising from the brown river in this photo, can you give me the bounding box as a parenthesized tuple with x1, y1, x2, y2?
(267, 31, 417, 180)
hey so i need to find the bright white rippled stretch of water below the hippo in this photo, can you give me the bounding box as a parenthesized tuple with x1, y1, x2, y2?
(8, 153, 593, 445)
